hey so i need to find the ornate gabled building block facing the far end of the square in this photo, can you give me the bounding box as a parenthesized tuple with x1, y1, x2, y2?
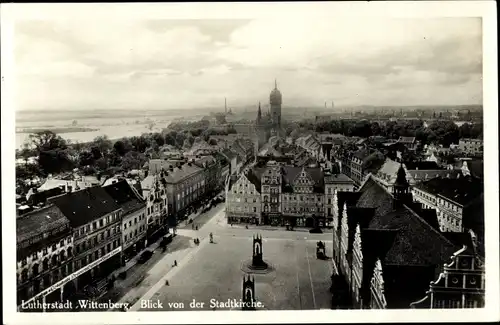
(226, 161, 327, 227)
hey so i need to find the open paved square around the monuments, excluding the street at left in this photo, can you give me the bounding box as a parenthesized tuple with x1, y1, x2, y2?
(139, 230, 333, 311)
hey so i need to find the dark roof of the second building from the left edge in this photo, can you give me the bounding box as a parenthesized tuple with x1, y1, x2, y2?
(49, 186, 120, 228)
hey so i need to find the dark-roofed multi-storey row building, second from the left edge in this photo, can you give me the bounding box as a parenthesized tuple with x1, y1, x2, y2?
(50, 186, 123, 302)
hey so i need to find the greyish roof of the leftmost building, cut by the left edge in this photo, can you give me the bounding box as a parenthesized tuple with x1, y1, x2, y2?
(16, 205, 69, 243)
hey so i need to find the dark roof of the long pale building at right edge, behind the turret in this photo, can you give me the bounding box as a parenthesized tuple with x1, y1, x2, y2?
(416, 176, 484, 206)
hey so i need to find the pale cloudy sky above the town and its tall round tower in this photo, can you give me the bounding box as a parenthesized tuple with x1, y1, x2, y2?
(14, 15, 483, 110)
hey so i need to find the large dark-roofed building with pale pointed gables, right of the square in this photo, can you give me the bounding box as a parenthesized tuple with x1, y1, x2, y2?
(334, 168, 458, 308)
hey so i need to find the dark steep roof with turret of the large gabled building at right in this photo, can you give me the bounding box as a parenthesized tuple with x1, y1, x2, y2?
(338, 173, 461, 308)
